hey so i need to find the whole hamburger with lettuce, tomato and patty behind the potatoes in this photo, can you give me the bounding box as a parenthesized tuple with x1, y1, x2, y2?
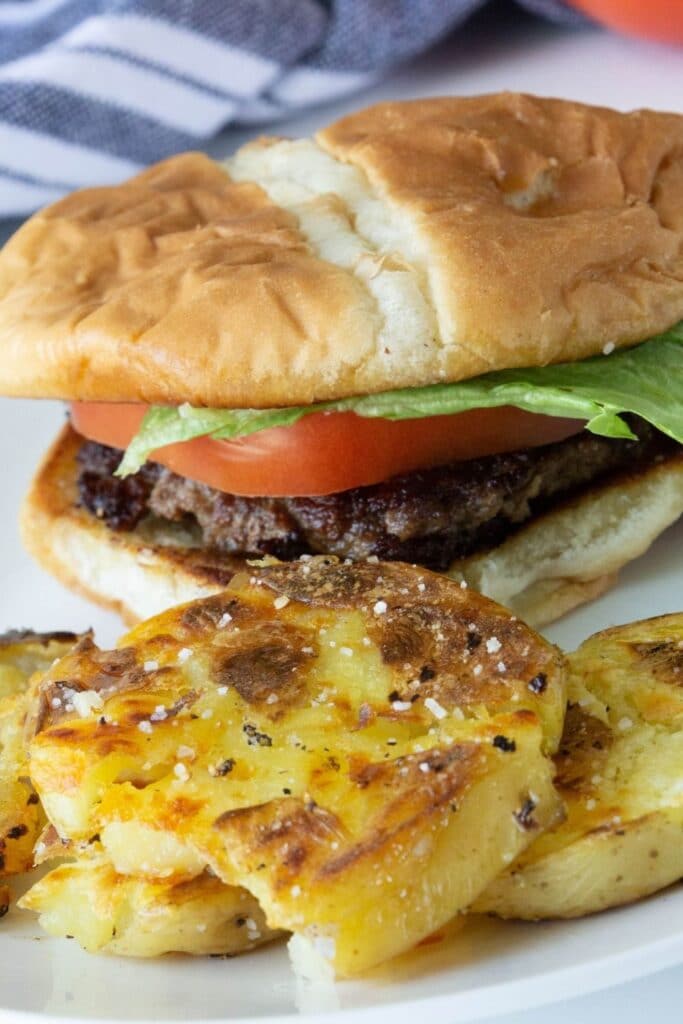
(0, 93, 683, 625)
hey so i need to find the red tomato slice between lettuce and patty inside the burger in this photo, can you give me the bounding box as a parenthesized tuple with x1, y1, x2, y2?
(71, 402, 583, 497)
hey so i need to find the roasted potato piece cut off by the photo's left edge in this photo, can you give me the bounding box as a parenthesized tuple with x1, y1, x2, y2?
(0, 631, 78, 884)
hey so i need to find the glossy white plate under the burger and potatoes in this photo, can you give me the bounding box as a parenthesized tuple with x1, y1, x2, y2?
(0, 400, 683, 1024)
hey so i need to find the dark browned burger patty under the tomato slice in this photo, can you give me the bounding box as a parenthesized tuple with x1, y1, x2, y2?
(78, 421, 675, 570)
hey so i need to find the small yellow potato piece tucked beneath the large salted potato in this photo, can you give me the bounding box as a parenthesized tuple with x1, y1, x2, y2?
(19, 854, 273, 956)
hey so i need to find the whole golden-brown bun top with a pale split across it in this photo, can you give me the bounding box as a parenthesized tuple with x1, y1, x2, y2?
(0, 93, 683, 408)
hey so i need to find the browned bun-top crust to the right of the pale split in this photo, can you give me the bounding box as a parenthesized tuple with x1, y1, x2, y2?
(318, 93, 683, 379)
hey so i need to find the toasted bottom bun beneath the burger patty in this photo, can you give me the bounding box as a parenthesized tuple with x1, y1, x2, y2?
(20, 426, 683, 626)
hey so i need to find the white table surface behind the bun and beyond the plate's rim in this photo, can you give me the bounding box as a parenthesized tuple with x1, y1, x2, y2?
(0, 6, 683, 1024)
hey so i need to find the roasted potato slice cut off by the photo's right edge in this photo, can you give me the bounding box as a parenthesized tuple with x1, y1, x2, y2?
(474, 614, 683, 919)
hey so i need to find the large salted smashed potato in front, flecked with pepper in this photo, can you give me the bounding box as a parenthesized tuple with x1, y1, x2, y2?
(27, 558, 565, 975)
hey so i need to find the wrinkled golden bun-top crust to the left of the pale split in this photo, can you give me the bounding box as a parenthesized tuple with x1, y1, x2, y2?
(0, 154, 374, 406)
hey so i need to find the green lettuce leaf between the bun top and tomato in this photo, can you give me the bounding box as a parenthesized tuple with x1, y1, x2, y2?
(117, 322, 683, 476)
